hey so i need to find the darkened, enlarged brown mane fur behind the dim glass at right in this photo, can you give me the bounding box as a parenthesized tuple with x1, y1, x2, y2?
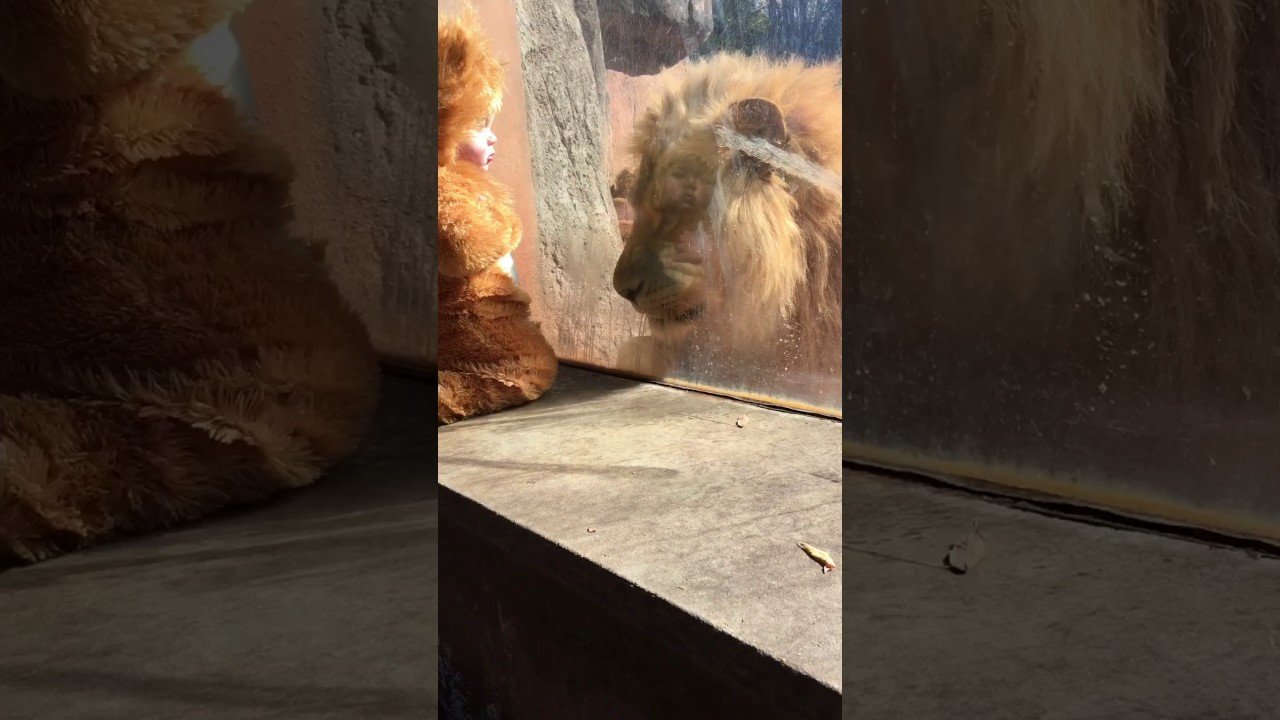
(850, 0, 1280, 389)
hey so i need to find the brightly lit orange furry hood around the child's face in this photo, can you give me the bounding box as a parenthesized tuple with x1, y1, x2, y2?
(439, 4, 503, 165)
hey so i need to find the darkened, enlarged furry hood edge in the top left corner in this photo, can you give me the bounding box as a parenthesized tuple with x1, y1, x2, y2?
(0, 0, 249, 100)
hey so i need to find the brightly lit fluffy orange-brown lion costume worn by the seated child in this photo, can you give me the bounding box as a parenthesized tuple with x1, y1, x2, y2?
(438, 9, 557, 424)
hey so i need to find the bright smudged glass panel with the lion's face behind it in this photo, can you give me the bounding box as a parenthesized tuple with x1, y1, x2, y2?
(453, 0, 842, 415)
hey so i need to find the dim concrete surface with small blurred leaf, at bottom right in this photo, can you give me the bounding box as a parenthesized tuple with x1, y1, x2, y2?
(842, 470, 1280, 720)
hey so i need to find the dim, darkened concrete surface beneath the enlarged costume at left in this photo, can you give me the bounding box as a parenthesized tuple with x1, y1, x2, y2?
(0, 377, 438, 720)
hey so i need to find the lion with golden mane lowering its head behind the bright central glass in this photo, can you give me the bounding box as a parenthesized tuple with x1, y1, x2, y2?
(613, 54, 842, 404)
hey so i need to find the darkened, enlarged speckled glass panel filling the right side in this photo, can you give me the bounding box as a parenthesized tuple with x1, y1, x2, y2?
(844, 0, 1280, 538)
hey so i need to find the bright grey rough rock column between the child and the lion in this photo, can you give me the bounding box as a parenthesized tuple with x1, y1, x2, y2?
(516, 0, 641, 365)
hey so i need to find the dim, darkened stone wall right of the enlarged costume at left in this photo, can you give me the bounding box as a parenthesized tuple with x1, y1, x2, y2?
(234, 0, 436, 368)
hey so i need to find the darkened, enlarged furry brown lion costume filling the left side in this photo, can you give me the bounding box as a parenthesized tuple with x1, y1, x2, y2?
(0, 0, 378, 564)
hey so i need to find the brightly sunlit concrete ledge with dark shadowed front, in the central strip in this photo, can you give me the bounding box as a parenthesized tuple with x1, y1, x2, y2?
(439, 368, 841, 720)
